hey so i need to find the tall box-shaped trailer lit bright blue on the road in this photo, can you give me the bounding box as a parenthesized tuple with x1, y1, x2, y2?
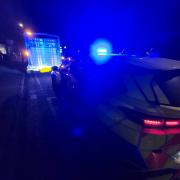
(24, 33, 61, 71)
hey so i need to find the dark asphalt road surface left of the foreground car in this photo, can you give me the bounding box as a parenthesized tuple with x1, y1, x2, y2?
(0, 67, 146, 180)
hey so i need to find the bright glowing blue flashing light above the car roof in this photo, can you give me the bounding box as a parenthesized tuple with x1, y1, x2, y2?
(90, 39, 112, 65)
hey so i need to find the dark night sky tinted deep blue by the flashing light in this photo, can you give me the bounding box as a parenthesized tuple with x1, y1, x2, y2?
(0, 0, 180, 57)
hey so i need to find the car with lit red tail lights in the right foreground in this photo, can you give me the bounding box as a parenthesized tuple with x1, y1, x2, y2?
(98, 57, 180, 174)
